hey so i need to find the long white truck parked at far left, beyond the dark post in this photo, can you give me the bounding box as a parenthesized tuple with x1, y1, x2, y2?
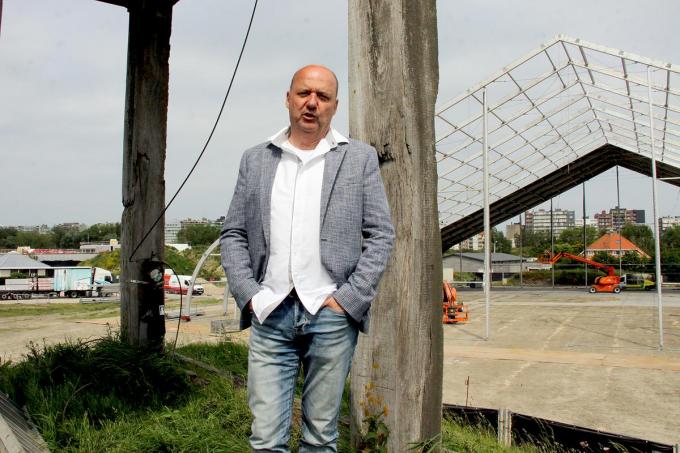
(0, 266, 113, 300)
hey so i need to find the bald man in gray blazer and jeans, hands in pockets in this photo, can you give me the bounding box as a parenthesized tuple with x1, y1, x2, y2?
(221, 65, 394, 453)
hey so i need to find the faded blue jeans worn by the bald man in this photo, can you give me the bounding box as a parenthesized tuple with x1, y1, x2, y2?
(248, 297, 358, 453)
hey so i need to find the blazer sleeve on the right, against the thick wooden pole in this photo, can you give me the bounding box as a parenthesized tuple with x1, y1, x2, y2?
(333, 148, 394, 322)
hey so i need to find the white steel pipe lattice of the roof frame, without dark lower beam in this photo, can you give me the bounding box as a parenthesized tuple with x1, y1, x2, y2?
(436, 36, 680, 237)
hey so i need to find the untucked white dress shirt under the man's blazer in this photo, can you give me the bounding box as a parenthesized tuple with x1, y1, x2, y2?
(252, 128, 347, 322)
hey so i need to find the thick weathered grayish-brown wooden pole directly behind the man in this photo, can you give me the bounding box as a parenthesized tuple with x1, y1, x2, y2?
(349, 0, 442, 452)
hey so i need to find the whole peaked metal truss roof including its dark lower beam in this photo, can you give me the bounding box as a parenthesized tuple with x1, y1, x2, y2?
(435, 36, 680, 249)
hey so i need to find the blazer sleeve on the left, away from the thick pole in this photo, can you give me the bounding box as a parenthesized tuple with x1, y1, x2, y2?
(220, 152, 260, 310)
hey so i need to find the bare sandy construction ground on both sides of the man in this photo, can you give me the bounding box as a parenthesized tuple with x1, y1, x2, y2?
(0, 285, 680, 444)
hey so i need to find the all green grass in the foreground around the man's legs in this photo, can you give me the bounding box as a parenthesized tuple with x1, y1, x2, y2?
(0, 336, 568, 453)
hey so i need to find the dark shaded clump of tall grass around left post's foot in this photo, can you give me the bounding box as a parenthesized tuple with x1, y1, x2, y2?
(0, 337, 194, 451)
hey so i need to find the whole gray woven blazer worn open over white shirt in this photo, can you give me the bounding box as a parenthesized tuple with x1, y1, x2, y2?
(220, 139, 394, 333)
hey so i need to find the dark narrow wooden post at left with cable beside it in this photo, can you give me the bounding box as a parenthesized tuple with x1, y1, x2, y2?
(120, 0, 174, 346)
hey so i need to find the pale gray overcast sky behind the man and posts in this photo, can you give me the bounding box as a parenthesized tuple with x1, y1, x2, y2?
(0, 0, 680, 230)
